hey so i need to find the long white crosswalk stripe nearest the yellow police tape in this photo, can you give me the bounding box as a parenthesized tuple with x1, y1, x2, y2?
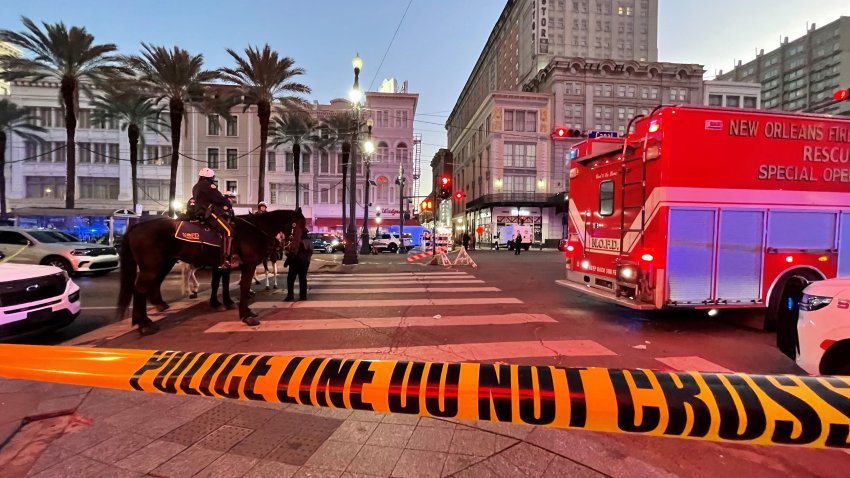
(253, 340, 617, 362)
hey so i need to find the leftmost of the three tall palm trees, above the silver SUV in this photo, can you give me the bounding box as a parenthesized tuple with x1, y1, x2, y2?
(0, 17, 118, 209)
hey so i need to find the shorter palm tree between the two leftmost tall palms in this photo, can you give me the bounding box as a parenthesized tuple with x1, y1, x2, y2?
(92, 85, 168, 211)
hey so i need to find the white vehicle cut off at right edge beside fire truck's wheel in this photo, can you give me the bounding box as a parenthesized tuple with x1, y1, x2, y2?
(791, 278, 850, 375)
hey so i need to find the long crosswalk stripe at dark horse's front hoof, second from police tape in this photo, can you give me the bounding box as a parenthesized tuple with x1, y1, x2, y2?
(204, 313, 557, 333)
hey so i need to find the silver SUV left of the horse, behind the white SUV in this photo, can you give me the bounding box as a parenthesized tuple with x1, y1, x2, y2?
(0, 227, 118, 275)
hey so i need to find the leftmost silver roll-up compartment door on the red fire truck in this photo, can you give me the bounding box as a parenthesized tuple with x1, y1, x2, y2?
(667, 208, 716, 305)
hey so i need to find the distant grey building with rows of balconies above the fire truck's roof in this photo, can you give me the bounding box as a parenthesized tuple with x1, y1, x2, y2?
(717, 16, 850, 115)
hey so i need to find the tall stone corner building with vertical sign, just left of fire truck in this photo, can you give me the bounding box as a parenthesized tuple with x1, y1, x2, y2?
(446, 0, 703, 244)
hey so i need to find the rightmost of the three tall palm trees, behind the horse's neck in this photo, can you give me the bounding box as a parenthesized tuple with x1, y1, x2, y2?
(221, 44, 310, 202)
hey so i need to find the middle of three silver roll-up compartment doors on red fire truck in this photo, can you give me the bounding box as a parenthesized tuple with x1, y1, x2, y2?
(715, 209, 764, 304)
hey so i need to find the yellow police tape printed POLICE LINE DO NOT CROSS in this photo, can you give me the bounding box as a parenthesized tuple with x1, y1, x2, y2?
(0, 345, 850, 448)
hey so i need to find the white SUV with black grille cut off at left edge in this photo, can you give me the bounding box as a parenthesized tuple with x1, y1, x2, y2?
(0, 260, 80, 339)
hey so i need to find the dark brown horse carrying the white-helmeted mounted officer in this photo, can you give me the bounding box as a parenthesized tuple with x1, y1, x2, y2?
(116, 209, 305, 335)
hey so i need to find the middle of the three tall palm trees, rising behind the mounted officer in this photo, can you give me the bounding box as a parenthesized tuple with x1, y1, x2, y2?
(121, 43, 219, 214)
